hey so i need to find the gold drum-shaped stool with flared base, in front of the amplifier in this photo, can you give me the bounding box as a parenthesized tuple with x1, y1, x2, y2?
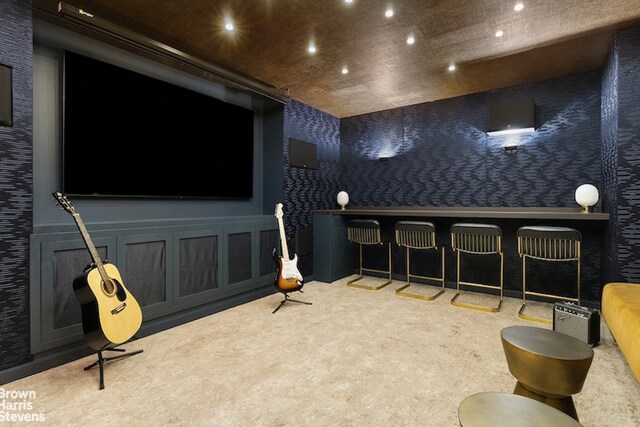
(500, 326, 593, 420)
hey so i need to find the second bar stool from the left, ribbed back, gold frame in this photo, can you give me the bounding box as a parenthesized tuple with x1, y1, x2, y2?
(395, 221, 445, 301)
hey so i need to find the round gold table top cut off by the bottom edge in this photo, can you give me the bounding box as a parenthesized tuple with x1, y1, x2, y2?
(458, 392, 582, 427)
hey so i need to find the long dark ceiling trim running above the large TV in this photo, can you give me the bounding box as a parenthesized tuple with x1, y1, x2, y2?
(53, 1, 289, 104)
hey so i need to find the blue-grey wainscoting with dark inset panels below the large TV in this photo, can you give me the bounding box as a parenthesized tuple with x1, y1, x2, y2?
(31, 215, 278, 357)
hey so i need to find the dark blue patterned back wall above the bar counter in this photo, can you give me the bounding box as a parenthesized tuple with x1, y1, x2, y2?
(340, 72, 602, 207)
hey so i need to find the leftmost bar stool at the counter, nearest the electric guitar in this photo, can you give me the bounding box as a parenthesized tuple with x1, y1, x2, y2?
(347, 219, 392, 291)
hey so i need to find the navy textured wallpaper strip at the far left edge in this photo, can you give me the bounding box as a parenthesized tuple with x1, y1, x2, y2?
(0, 0, 33, 370)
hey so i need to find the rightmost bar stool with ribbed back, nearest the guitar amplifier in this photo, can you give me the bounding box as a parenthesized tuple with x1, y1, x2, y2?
(516, 226, 582, 324)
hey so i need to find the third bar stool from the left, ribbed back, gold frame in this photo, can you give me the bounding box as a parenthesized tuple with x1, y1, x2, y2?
(451, 223, 504, 313)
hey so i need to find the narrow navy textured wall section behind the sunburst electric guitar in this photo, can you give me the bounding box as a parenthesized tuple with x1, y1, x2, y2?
(283, 101, 340, 276)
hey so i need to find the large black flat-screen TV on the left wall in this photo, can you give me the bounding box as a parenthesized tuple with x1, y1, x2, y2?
(62, 51, 254, 199)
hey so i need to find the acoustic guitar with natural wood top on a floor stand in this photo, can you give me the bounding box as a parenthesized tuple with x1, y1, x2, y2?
(53, 192, 142, 351)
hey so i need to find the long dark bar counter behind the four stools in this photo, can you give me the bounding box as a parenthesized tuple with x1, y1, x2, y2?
(313, 206, 609, 306)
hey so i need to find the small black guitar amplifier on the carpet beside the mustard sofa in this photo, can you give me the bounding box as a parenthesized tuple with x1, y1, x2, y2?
(553, 302, 600, 347)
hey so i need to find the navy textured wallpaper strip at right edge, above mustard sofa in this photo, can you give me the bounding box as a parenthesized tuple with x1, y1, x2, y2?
(614, 27, 640, 283)
